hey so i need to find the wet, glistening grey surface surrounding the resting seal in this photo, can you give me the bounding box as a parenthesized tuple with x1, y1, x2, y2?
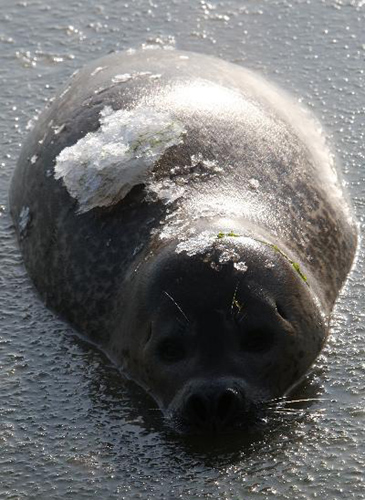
(0, 0, 365, 500)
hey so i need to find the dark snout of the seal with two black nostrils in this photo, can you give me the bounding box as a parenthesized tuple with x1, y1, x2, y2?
(173, 383, 250, 433)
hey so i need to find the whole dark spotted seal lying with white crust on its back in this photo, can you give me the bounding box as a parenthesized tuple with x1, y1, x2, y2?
(10, 50, 357, 433)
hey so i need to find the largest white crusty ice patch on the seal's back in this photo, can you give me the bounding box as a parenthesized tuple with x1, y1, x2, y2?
(54, 106, 185, 213)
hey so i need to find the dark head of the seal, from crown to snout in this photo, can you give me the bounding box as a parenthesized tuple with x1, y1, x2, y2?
(114, 236, 326, 432)
